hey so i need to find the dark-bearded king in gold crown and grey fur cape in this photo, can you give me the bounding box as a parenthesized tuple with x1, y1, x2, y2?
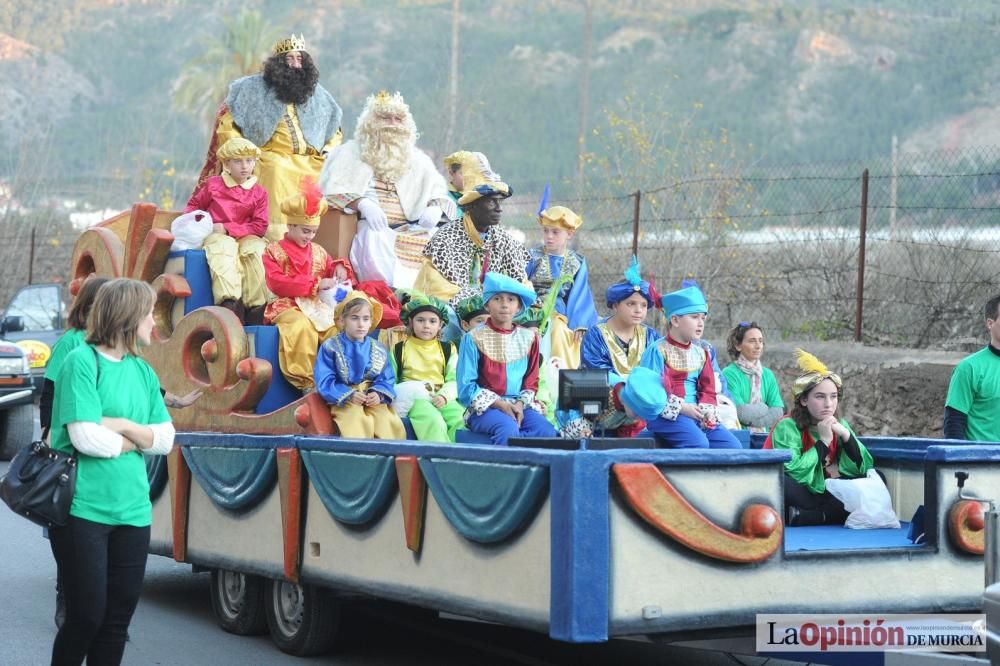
(199, 34, 343, 241)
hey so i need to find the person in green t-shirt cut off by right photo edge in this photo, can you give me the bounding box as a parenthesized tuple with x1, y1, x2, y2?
(944, 295, 1000, 442)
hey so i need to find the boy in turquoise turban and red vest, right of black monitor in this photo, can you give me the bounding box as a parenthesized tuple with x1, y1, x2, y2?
(640, 287, 742, 449)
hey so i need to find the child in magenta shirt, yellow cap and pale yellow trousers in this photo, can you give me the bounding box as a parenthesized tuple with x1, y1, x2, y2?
(184, 137, 268, 324)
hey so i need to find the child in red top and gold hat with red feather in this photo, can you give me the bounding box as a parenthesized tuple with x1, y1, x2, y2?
(264, 181, 350, 392)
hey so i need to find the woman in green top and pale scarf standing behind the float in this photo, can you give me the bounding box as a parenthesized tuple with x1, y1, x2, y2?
(722, 321, 785, 432)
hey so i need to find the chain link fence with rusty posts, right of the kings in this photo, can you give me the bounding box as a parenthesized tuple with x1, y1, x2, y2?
(513, 147, 1000, 347)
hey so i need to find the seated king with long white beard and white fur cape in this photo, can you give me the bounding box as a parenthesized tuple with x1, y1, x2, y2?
(319, 90, 457, 289)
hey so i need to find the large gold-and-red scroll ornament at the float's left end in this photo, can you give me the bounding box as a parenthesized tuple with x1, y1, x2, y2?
(70, 203, 333, 435)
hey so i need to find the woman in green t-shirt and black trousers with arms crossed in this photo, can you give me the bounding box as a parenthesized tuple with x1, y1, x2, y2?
(49, 278, 174, 664)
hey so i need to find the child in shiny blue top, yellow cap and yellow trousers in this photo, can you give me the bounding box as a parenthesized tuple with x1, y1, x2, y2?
(314, 291, 406, 439)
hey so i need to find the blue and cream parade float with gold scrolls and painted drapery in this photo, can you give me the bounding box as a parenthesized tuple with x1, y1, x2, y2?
(71, 204, 1000, 655)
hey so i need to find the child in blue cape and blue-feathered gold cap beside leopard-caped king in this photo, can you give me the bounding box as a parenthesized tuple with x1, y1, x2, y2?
(527, 206, 597, 369)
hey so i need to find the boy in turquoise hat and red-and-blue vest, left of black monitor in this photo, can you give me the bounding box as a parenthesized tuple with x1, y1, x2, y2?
(457, 273, 557, 446)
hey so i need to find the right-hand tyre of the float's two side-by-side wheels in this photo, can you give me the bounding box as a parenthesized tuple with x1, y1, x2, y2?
(265, 580, 340, 657)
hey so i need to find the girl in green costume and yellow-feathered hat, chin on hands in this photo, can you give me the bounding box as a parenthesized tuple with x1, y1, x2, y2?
(764, 349, 874, 526)
